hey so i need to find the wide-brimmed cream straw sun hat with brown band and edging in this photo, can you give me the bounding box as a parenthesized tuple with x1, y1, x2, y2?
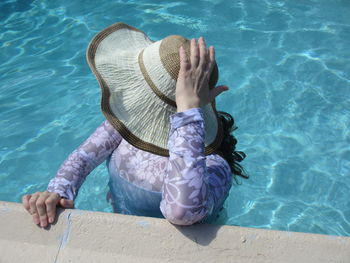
(86, 23, 222, 156)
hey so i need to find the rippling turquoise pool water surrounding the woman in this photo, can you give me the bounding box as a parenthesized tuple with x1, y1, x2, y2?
(0, 0, 350, 236)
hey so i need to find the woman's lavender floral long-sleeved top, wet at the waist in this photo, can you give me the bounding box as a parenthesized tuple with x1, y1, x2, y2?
(47, 108, 232, 225)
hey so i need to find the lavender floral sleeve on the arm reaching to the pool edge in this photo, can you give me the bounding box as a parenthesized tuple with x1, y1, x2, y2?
(47, 120, 122, 200)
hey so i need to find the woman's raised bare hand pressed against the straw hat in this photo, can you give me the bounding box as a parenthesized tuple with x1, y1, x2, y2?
(175, 37, 228, 112)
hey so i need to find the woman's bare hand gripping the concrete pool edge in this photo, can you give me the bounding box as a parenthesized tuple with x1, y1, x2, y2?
(22, 191, 74, 227)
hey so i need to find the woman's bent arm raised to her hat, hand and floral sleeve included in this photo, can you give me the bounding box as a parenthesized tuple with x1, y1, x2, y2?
(160, 38, 232, 225)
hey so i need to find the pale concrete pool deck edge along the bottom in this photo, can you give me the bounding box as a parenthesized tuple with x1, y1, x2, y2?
(0, 201, 350, 263)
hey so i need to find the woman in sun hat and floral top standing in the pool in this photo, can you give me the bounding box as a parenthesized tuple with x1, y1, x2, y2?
(22, 23, 247, 227)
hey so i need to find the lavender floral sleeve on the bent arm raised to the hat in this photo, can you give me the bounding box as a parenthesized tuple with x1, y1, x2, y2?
(160, 108, 232, 225)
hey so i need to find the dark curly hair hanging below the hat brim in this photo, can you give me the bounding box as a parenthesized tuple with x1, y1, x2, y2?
(217, 111, 249, 184)
